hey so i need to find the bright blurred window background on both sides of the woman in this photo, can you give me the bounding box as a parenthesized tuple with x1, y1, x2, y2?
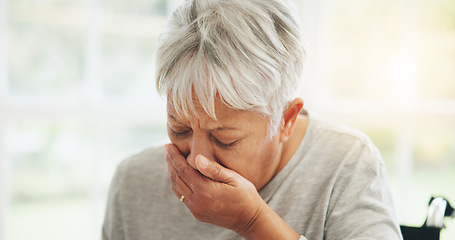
(0, 0, 455, 240)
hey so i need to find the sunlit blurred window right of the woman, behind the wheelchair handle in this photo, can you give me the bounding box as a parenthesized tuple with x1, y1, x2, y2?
(300, 0, 455, 239)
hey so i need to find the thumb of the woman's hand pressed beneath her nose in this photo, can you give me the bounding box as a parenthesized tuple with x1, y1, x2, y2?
(196, 154, 236, 184)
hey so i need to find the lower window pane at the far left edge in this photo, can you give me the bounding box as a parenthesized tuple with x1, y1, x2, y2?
(5, 121, 94, 240)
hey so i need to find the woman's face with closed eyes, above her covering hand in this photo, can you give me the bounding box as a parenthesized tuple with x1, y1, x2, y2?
(167, 99, 281, 190)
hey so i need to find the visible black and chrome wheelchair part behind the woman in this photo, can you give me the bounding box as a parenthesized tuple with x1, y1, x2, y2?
(400, 197, 455, 240)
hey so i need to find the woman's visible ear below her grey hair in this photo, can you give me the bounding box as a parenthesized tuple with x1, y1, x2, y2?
(280, 98, 303, 142)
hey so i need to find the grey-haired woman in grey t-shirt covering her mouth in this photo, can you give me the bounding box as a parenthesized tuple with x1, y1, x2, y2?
(103, 0, 401, 240)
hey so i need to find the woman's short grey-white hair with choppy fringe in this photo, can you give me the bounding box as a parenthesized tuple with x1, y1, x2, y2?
(156, 0, 305, 137)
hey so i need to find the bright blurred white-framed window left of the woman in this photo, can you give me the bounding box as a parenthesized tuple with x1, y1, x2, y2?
(0, 0, 176, 239)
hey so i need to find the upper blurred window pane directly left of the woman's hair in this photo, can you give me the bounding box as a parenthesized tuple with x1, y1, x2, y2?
(101, 0, 166, 100)
